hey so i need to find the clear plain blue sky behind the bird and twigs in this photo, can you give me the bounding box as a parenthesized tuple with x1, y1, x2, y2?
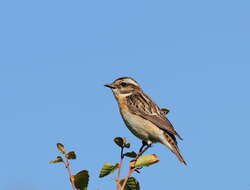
(0, 0, 250, 190)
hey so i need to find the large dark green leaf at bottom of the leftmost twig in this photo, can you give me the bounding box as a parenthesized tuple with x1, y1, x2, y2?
(70, 170, 89, 190)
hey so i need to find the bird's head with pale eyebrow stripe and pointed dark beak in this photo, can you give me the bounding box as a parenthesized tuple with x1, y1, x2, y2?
(104, 77, 140, 96)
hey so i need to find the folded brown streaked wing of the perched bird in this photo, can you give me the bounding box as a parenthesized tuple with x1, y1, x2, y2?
(127, 93, 182, 140)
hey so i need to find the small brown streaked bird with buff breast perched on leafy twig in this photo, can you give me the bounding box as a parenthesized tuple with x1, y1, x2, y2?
(104, 77, 187, 165)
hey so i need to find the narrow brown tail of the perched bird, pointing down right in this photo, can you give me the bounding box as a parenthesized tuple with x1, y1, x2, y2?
(163, 133, 187, 165)
